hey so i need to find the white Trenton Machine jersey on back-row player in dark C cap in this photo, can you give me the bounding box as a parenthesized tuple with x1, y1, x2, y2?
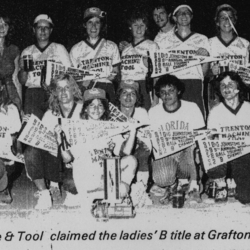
(70, 39, 121, 81)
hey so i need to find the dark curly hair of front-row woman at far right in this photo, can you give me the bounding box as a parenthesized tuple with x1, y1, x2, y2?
(215, 71, 248, 102)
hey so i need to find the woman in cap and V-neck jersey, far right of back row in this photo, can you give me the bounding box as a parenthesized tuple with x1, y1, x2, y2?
(209, 4, 249, 108)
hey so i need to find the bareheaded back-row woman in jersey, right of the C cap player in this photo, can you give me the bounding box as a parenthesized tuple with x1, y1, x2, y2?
(121, 12, 158, 110)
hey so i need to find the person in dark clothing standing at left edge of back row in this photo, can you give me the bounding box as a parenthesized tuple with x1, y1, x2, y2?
(0, 15, 22, 111)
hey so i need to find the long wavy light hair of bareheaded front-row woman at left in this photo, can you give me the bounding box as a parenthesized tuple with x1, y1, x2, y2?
(49, 73, 82, 115)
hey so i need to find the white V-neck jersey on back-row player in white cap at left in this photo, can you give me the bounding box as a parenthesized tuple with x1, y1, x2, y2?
(21, 43, 71, 88)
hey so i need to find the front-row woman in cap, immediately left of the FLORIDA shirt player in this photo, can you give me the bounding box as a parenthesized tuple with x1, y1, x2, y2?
(116, 80, 152, 207)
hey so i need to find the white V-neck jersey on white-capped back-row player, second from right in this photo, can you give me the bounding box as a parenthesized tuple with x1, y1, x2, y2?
(164, 31, 209, 80)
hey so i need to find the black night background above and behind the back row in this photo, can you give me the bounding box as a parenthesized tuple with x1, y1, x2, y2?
(0, 0, 250, 50)
